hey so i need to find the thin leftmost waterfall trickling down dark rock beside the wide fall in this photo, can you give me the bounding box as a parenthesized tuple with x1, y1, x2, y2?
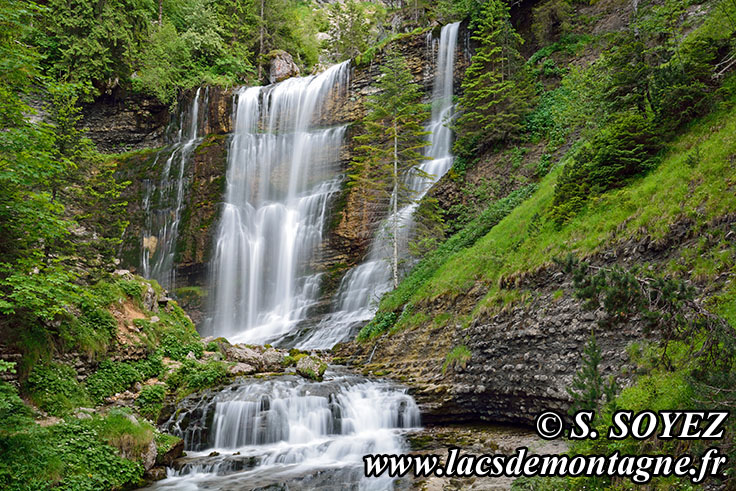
(141, 88, 209, 288)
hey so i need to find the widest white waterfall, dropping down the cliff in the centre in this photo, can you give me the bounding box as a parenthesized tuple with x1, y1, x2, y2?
(210, 62, 349, 343)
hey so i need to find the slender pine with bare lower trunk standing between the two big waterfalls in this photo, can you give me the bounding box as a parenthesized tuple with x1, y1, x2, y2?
(350, 50, 429, 287)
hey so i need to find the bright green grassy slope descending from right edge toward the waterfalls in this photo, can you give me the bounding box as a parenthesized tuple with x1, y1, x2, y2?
(376, 90, 736, 334)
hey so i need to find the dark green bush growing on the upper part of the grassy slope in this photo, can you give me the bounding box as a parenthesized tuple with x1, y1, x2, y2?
(551, 112, 660, 223)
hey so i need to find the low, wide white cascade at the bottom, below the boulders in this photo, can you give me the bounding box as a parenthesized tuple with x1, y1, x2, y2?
(145, 370, 420, 490)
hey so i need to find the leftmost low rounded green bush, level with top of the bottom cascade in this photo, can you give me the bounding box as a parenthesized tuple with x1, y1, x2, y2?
(24, 363, 90, 416)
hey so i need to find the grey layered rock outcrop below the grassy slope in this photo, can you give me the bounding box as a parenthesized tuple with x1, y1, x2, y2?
(335, 214, 736, 424)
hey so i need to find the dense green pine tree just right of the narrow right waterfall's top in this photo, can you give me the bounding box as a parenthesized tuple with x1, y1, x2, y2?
(455, 0, 532, 157)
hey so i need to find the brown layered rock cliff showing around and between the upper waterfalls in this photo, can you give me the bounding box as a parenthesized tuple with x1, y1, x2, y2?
(108, 24, 468, 330)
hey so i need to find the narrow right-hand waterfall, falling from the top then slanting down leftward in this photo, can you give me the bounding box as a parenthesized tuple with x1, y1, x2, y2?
(297, 22, 460, 349)
